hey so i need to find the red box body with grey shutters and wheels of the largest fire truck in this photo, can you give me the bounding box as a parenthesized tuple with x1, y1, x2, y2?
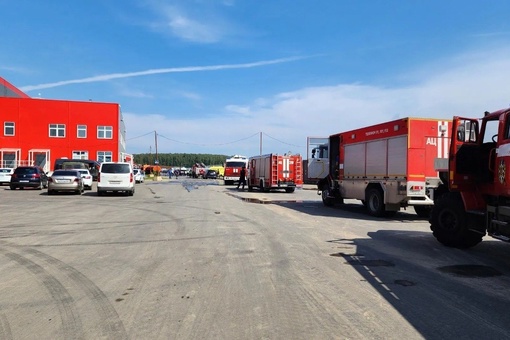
(317, 118, 451, 217)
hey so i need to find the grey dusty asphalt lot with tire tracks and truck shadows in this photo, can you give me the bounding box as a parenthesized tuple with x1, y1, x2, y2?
(0, 177, 510, 339)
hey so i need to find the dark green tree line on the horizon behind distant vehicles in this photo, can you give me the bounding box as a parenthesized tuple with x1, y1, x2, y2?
(133, 153, 229, 168)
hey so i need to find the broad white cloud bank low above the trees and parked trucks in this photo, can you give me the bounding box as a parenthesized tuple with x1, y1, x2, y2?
(126, 45, 510, 156)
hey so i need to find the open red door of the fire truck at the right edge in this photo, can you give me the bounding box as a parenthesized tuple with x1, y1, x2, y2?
(448, 116, 480, 191)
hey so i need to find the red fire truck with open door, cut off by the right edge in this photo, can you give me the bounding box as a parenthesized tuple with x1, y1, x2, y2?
(430, 109, 510, 248)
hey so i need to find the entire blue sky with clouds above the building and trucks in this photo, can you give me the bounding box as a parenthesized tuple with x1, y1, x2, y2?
(0, 0, 510, 158)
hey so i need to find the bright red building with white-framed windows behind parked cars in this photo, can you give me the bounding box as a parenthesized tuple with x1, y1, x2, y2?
(0, 78, 127, 171)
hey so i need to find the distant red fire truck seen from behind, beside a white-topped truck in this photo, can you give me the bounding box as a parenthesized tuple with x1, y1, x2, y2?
(246, 153, 303, 193)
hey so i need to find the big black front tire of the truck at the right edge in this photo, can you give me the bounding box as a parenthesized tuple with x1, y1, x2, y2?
(429, 193, 483, 249)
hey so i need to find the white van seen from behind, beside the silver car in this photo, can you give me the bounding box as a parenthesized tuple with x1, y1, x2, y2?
(97, 162, 135, 196)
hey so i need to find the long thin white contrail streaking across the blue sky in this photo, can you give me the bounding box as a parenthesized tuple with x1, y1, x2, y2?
(20, 57, 306, 92)
